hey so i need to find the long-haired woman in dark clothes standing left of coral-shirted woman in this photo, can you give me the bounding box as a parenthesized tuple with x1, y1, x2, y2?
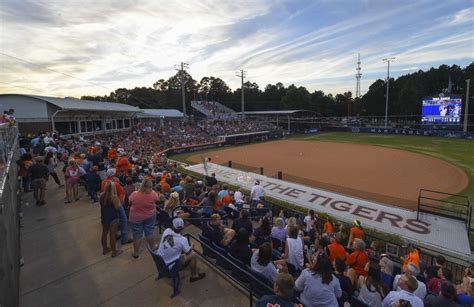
(100, 182, 122, 257)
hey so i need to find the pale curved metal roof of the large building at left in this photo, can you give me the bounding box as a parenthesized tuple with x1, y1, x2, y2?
(0, 94, 142, 112)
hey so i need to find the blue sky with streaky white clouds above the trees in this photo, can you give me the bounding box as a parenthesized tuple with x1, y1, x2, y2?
(0, 0, 474, 97)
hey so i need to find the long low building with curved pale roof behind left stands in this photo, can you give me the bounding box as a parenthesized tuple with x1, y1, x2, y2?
(0, 94, 143, 135)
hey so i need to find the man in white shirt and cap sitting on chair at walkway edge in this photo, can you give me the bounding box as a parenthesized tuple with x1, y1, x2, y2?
(155, 218, 206, 282)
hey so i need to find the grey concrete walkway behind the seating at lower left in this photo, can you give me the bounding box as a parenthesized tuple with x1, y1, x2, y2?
(20, 180, 248, 307)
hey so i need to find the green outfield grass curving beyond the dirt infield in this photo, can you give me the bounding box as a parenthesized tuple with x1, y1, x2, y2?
(303, 132, 474, 200)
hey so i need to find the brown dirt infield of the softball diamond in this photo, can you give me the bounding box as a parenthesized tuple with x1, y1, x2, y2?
(188, 140, 469, 210)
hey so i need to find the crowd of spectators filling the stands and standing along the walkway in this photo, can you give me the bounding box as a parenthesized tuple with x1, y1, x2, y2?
(18, 128, 474, 307)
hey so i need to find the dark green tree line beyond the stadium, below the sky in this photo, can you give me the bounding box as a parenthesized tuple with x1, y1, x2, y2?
(81, 62, 474, 116)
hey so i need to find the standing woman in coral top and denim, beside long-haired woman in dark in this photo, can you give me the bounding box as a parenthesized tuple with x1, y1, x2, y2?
(128, 179, 158, 259)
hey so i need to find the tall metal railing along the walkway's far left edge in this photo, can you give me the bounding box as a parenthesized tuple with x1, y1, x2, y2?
(0, 126, 20, 306)
